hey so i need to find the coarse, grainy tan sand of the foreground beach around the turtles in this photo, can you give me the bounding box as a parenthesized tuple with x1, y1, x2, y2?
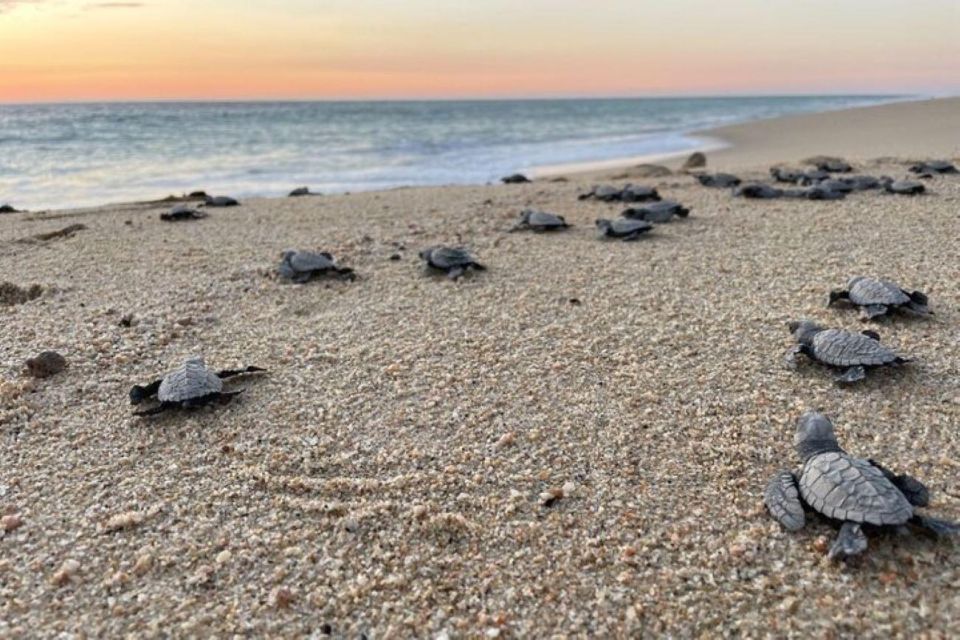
(0, 97, 960, 638)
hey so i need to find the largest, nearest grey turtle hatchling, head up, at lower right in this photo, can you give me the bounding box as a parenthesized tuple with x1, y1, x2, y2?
(763, 411, 960, 560)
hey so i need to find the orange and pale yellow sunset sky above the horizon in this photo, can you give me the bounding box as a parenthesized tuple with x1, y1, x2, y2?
(0, 0, 960, 102)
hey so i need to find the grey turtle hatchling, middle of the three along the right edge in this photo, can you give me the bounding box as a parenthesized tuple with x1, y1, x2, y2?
(787, 320, 910, 383)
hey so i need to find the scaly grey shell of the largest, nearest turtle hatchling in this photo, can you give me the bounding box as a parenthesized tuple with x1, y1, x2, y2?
(800, 451, 913, 526)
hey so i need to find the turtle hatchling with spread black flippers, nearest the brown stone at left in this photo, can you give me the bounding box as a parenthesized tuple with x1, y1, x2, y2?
(130, 357, 266, 416)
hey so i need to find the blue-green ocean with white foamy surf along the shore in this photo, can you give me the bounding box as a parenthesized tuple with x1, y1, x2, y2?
(0, 96, 897, 210)
